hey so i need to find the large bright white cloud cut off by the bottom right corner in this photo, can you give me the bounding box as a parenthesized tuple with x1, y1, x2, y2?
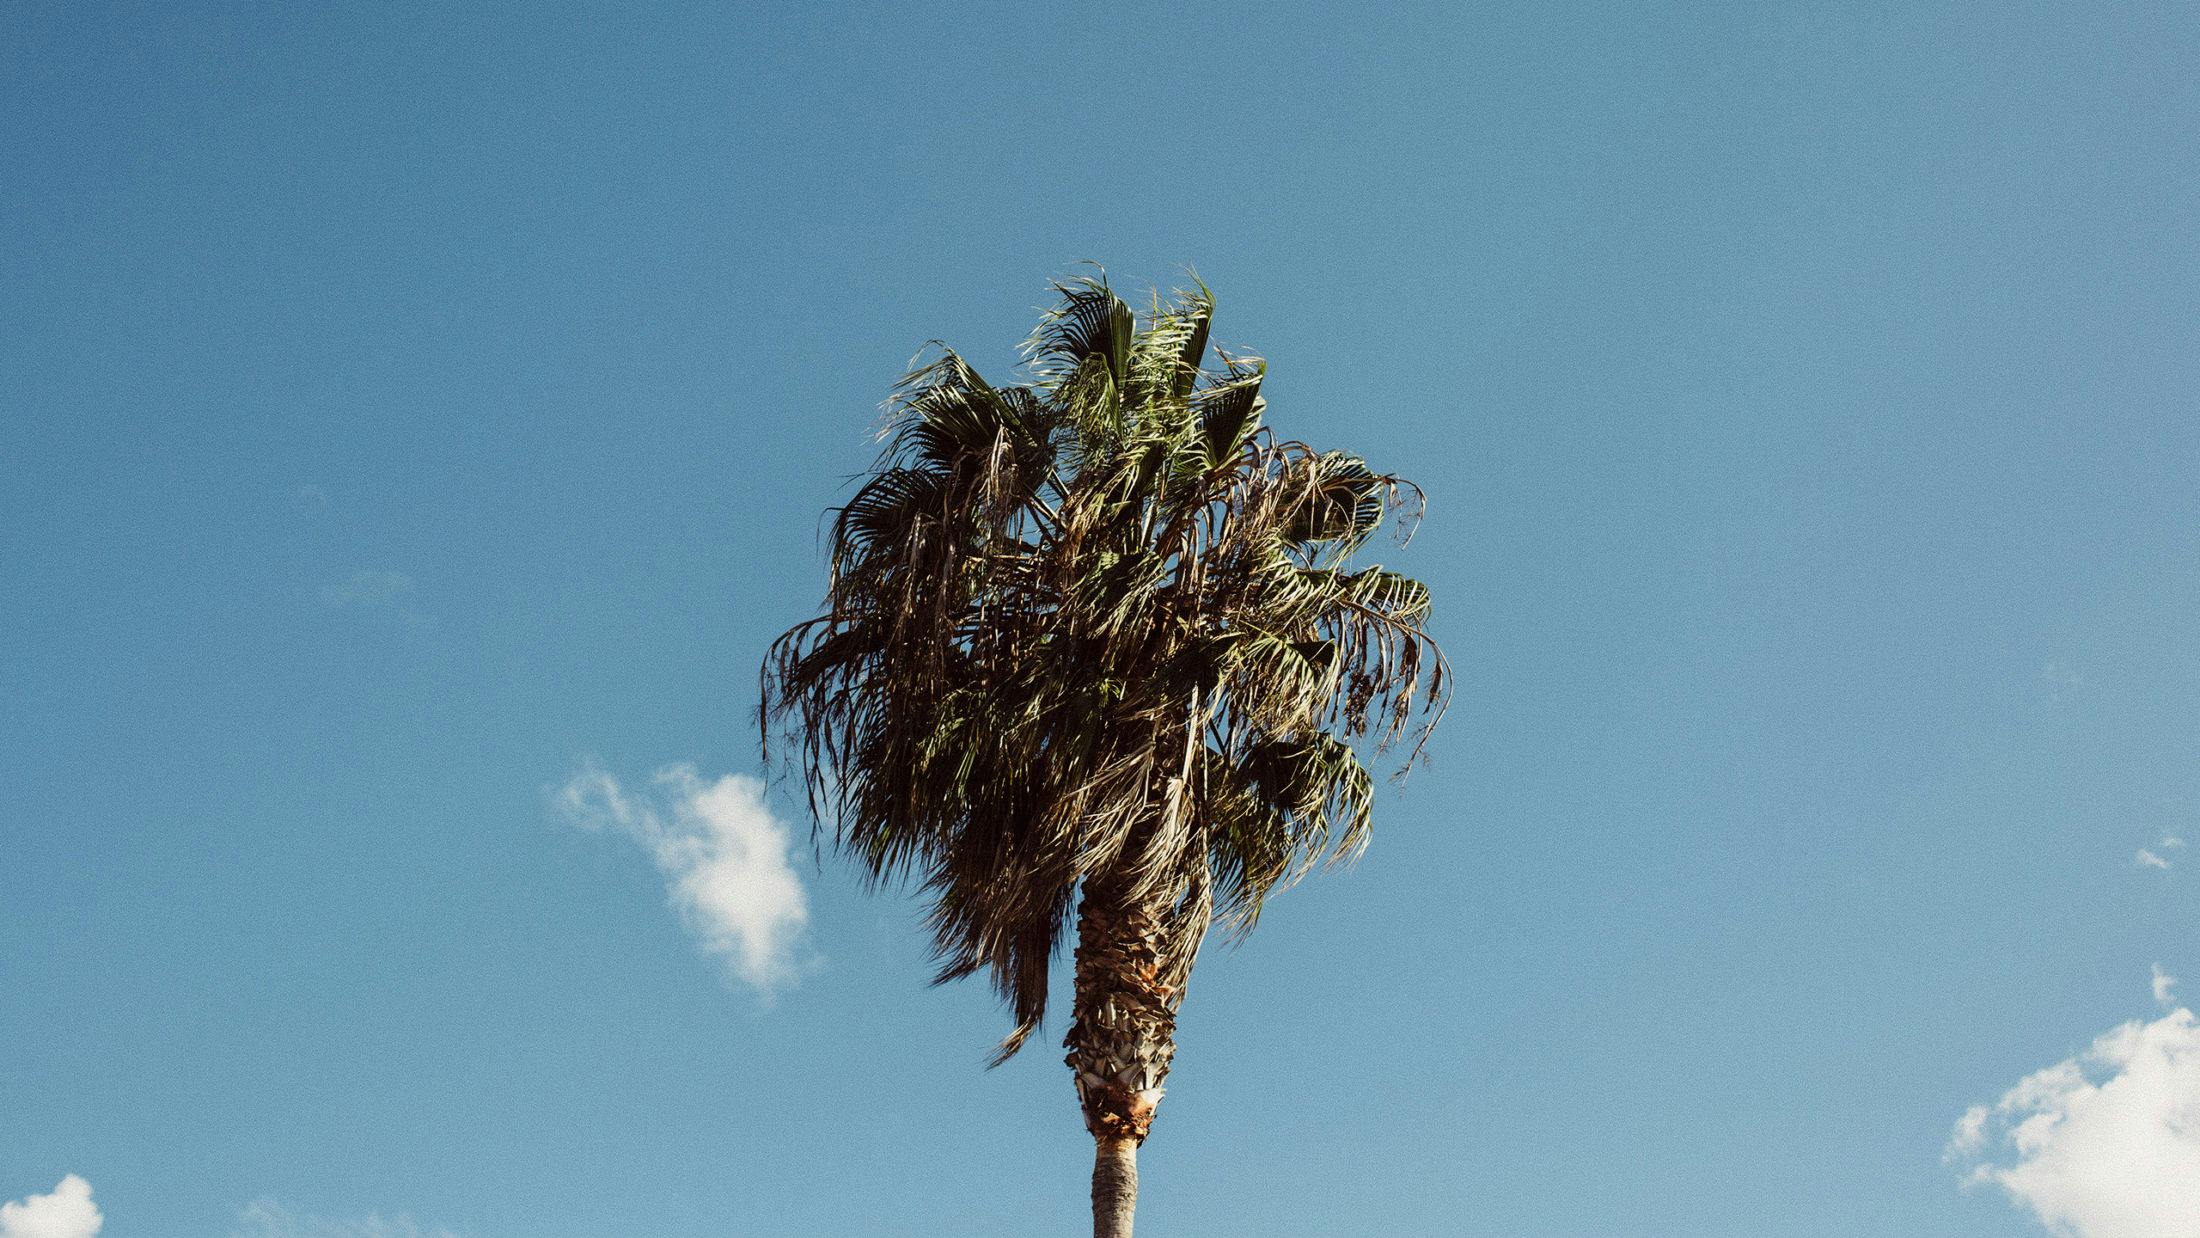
(1947, 989, 2200, 1238)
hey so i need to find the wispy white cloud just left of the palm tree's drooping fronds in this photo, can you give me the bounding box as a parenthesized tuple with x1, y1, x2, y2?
(557, 765, 810, 992)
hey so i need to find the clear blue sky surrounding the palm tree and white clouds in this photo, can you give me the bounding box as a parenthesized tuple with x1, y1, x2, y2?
(0, 2, 2200, 1238)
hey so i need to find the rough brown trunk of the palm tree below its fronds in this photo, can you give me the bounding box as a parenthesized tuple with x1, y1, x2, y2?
(1063, 886, 1184, 1238)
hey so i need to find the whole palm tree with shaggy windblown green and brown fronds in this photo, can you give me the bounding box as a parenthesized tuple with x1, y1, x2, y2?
(759, 277, 1448, 1238)
